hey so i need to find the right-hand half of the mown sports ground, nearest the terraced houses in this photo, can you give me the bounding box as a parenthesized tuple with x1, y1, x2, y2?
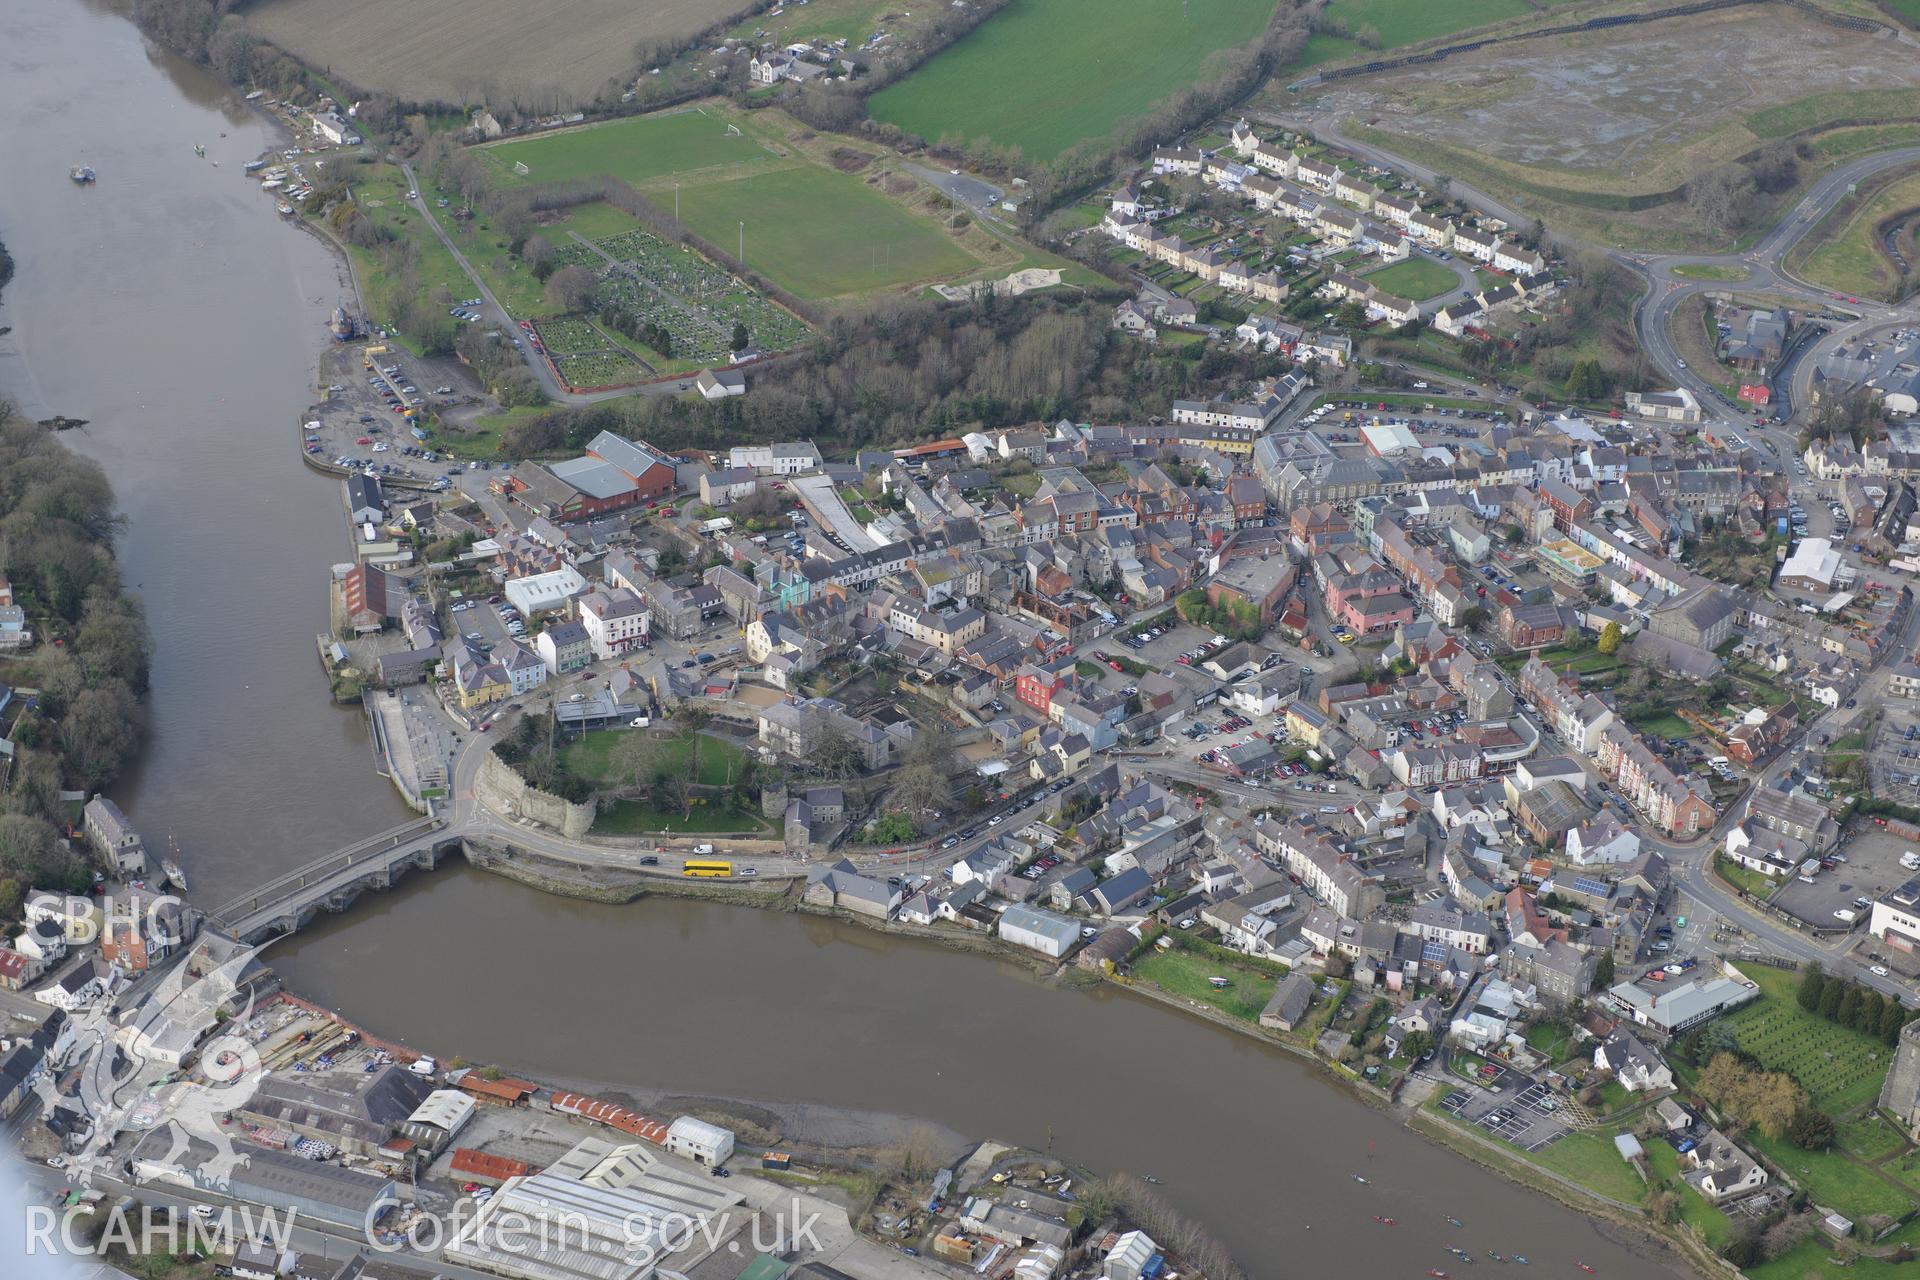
(680, 165, 975, 297)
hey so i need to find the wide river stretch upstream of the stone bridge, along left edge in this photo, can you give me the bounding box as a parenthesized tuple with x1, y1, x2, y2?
(0, 0, 409, 902)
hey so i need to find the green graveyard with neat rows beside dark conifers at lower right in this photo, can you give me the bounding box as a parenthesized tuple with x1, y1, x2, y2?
(1726, 965, 1893, 1113)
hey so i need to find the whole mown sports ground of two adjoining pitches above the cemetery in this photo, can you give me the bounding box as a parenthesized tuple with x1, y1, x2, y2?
(480, 107, 979, 297)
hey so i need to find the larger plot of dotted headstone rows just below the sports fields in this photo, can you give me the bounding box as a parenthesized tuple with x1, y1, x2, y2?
(591, 230, 806, 365)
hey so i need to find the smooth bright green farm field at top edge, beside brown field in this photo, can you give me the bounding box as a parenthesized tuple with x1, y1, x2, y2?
(868, 0, 1290, 163)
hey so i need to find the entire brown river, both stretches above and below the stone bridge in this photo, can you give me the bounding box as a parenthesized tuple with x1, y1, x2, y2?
(0, 0, 1688, 1276)
